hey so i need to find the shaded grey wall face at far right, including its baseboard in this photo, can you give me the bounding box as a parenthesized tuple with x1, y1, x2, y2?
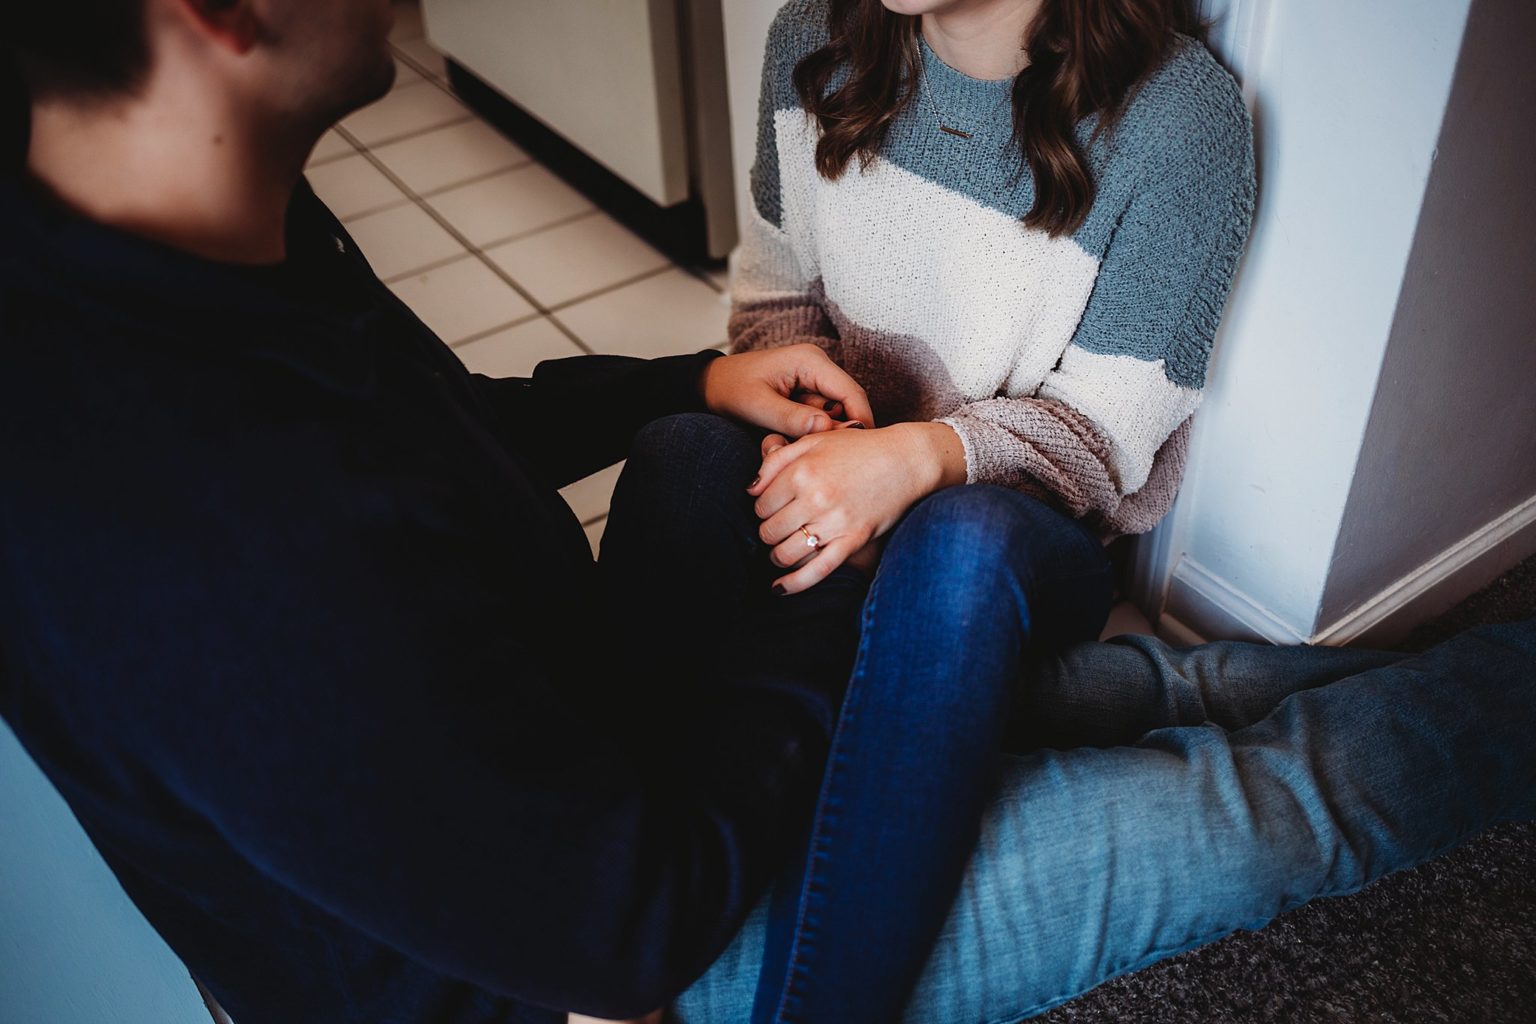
(1319, 0, 1536, 642)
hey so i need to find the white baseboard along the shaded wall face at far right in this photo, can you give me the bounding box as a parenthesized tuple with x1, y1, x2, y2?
(1310, 494, 1536, 646)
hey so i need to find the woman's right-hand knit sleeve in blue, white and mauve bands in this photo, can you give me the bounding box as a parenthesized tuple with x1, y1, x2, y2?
(940, 80, 1255, 533)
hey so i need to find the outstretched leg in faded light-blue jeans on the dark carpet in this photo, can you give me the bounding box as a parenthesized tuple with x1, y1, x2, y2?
(674, 622, 1536, 1024)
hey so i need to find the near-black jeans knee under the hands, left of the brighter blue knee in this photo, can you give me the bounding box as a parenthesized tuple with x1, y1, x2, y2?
(594, 413, 868, 746)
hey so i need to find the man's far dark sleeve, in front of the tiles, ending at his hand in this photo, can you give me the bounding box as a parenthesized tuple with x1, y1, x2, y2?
(473, 350, 722, 487)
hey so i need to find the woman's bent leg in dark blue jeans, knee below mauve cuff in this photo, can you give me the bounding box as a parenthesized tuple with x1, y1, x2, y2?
(740, 485, 1111, 1024)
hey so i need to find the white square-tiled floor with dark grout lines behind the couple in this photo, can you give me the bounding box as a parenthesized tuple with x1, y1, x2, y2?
(309, 3, 730, 550)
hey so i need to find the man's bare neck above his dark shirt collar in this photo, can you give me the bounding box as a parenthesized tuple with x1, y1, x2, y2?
(28, 78, 313, 264)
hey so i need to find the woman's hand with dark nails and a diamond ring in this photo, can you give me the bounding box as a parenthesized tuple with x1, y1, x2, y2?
(746, 421, 966, 594)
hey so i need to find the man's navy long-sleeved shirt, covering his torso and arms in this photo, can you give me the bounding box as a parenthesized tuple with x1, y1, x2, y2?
(0, 142, 837, 1024)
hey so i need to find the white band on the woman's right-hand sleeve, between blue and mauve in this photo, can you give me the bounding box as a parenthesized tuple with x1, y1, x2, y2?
(1040, 348, 1200, 494)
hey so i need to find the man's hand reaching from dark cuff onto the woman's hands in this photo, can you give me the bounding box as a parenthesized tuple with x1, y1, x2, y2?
(699, 344, 874, 438)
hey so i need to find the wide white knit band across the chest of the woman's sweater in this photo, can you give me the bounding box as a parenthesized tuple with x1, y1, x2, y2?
(776, 111, 1098, 401)
